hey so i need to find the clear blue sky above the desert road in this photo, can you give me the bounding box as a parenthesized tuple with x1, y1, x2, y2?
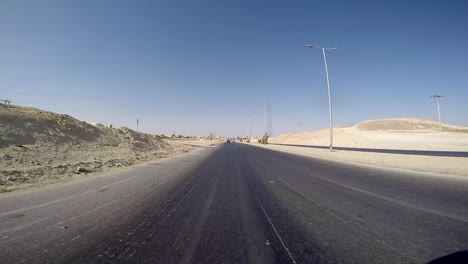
(0, 0, 468, 136)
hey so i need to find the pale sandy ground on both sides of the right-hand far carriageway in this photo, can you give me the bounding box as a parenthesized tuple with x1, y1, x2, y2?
(262, 118, 468, 176)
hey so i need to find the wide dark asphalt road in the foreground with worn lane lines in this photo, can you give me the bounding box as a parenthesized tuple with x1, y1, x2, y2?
(0, 143, 468, 263)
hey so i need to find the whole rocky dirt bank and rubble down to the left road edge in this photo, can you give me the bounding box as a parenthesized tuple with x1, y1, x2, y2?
(0, 104, 191, 192)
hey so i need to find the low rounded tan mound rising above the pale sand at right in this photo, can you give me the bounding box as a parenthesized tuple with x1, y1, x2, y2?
(355, 118, 439, 131)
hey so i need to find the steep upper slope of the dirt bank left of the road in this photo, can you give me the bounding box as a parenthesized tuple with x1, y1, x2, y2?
(0, 105, 167, 149)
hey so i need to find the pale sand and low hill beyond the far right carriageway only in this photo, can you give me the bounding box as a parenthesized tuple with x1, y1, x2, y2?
(268, 118, 468, 151)
